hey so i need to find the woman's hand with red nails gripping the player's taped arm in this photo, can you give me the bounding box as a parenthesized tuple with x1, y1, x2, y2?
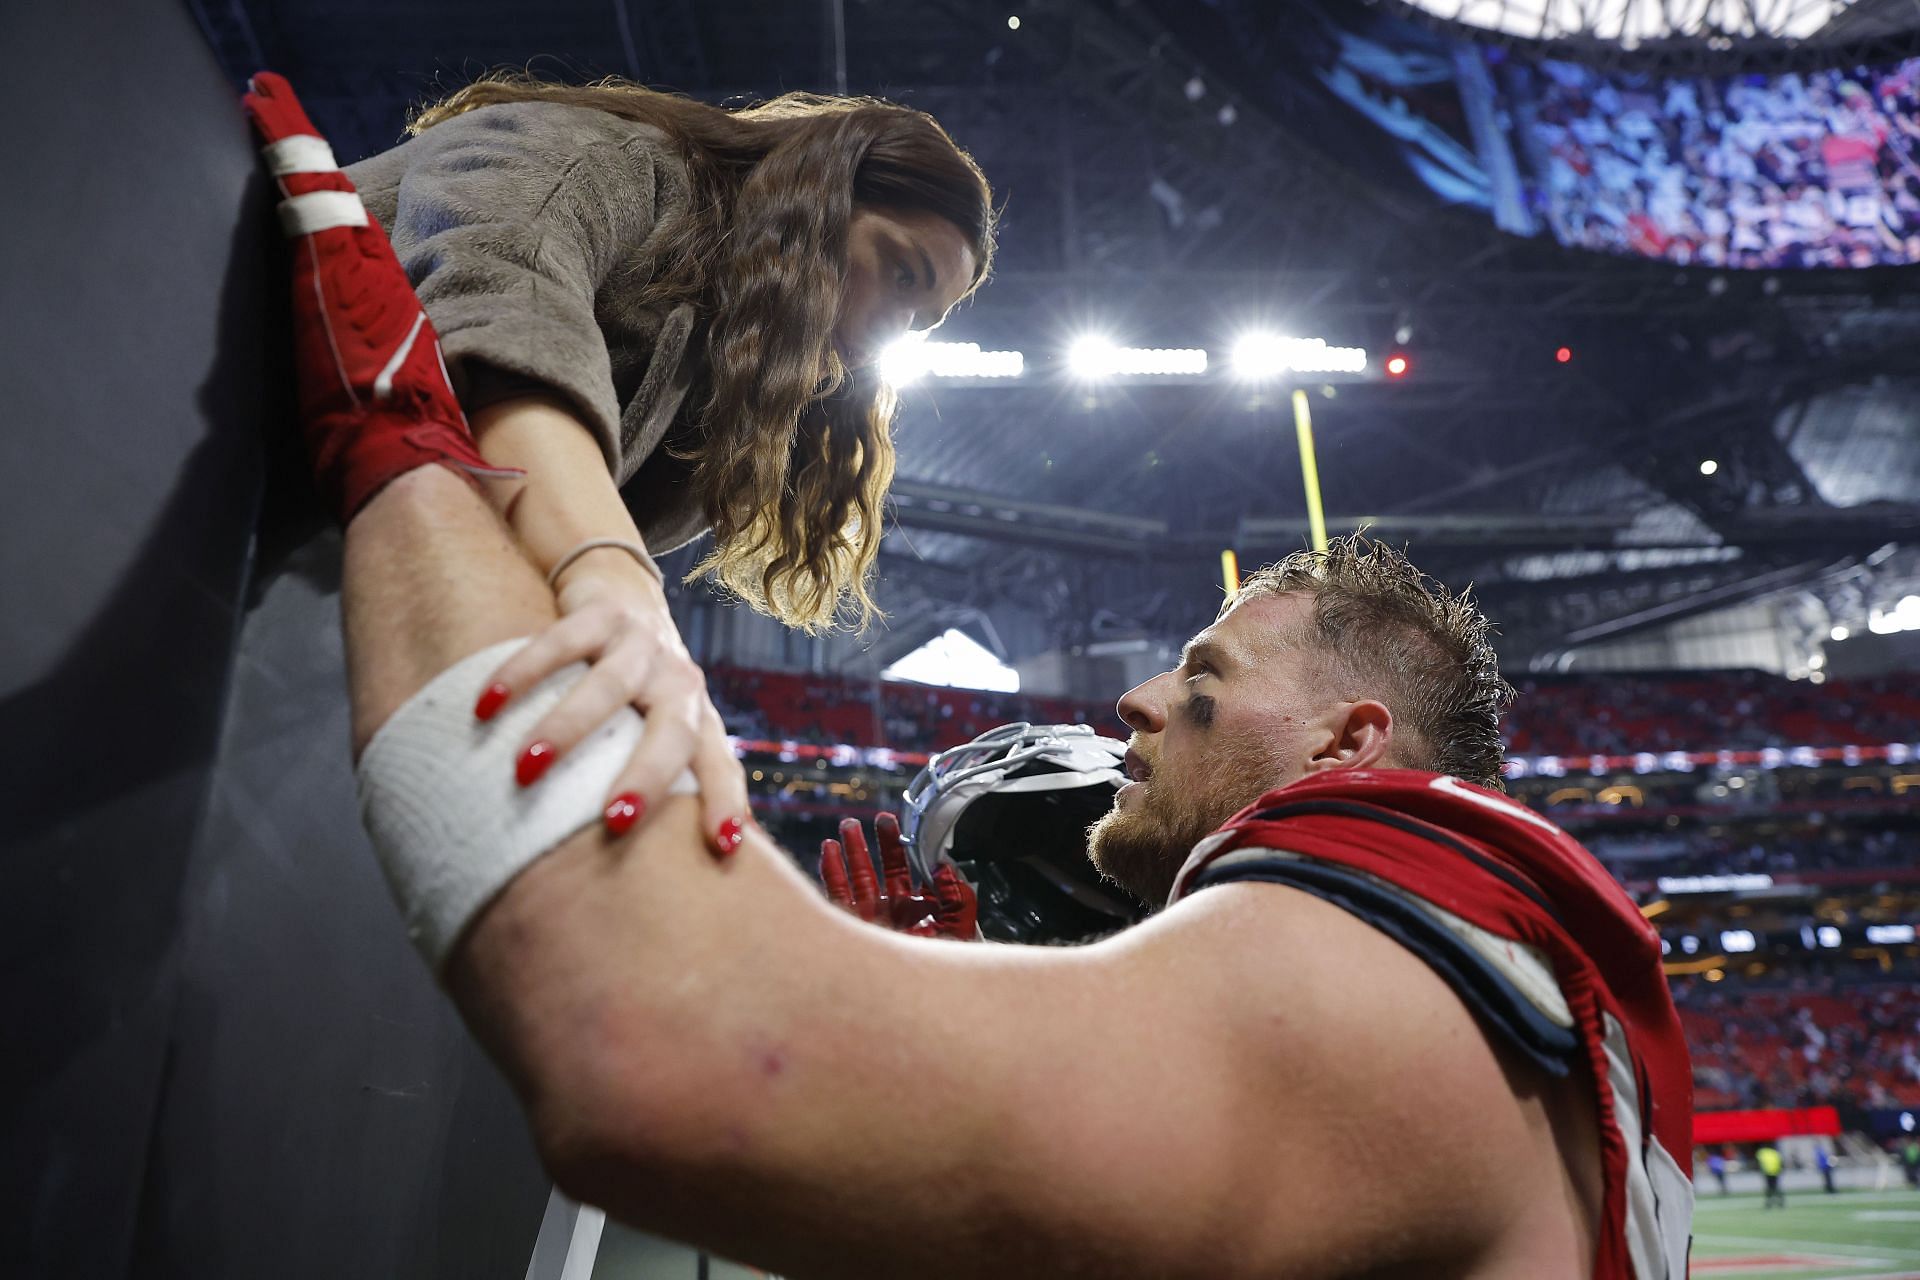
(474, 547, 747, 856)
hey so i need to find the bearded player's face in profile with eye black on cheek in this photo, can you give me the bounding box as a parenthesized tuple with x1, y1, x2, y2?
(1089, 595, 1340, 906)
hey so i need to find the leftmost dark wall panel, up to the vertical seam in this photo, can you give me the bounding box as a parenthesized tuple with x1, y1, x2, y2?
(0, 0, 271, 1276)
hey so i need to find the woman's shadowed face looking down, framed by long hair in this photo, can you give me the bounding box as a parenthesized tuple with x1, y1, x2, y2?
(833, 205, 975, 368)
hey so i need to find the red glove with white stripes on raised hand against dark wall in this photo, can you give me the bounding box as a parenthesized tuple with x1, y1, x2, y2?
(242, 71, 524, 524)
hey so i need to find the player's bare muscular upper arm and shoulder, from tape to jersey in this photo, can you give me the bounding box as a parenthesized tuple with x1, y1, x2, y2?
(449, 798, 1540, 1276)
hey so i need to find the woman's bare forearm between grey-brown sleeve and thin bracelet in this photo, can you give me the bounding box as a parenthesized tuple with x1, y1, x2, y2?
(472, 395, 643, 572)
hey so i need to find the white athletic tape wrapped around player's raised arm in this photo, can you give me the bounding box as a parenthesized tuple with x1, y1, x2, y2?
(359, 639, 699, 975)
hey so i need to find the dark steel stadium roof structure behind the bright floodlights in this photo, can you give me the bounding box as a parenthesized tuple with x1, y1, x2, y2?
(196, 0, 1920, 666)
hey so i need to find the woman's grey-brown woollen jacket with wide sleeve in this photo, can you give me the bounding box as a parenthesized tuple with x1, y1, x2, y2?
(348, 102, 707, 551)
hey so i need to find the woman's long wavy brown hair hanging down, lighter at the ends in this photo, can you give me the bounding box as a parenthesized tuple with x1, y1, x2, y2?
(407, 73, 995, 631)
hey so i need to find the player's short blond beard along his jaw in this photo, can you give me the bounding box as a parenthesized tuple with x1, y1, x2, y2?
(1087, 741, 1281, 910)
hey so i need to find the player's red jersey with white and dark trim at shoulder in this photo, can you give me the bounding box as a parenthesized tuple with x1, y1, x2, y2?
(1169, 770, 1693, 1280)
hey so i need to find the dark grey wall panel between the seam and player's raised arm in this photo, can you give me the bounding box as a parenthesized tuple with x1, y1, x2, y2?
(138, 537, 549, 1280)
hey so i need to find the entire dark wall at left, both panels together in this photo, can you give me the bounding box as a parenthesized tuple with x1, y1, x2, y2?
(0, 0, 547, 1280)
